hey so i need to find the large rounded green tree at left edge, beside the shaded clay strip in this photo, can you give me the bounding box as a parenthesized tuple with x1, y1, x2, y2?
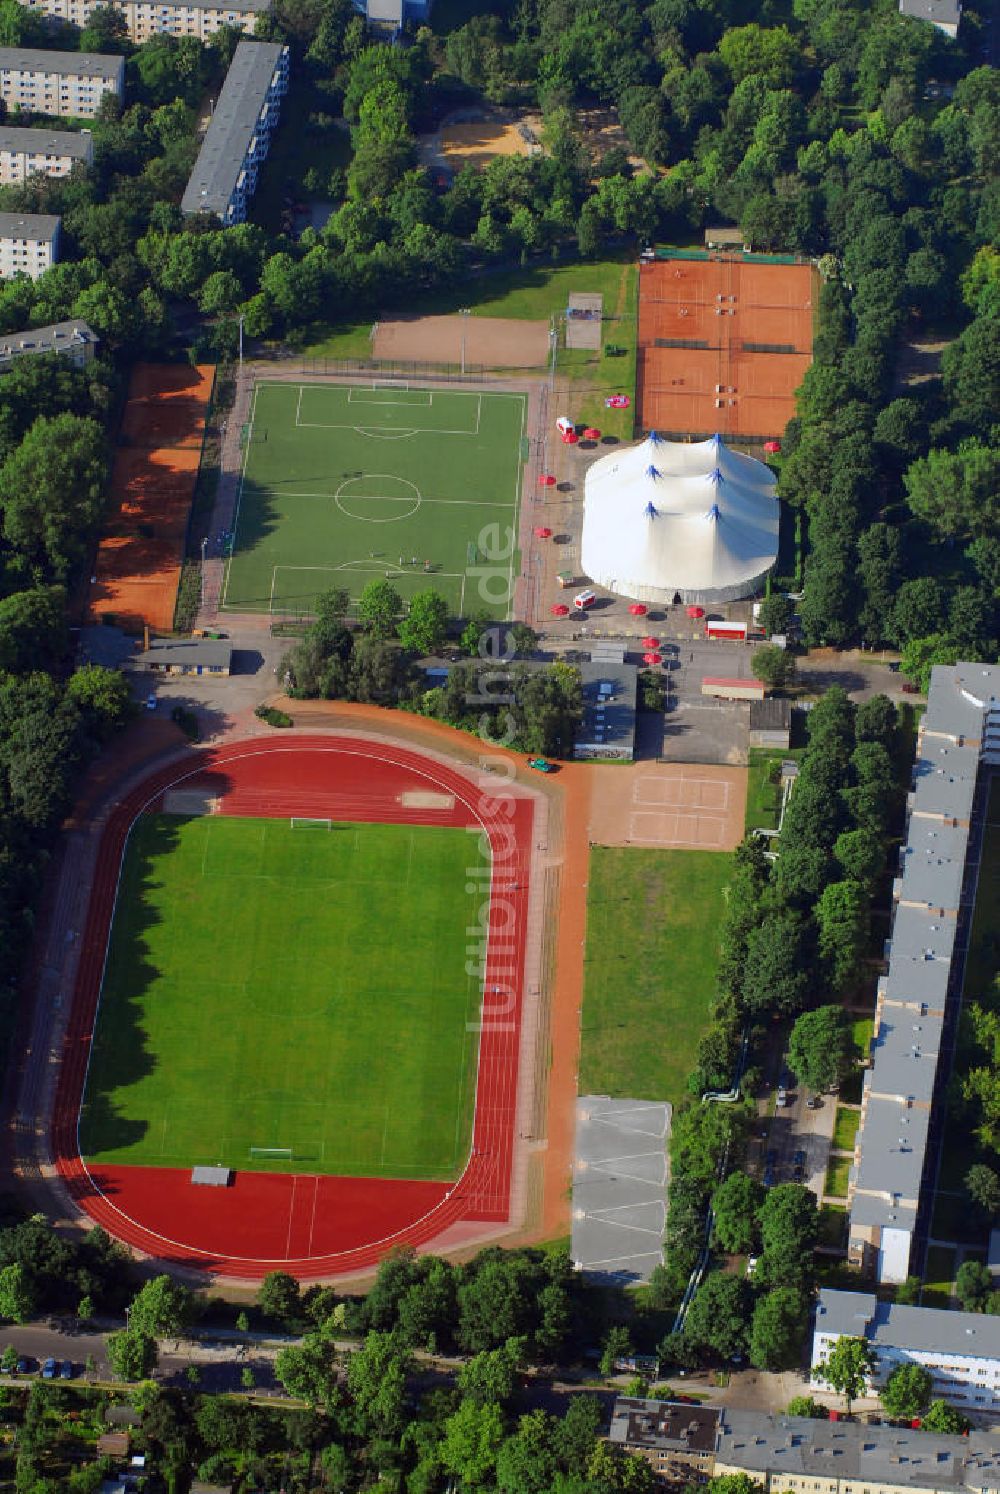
(0, 414, 105, 581)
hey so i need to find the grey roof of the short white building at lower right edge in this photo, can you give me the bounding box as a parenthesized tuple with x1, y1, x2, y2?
(816, 1288, 1000, 1360)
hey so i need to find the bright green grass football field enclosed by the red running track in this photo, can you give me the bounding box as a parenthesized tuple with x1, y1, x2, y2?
(81, 814, 481, 1179)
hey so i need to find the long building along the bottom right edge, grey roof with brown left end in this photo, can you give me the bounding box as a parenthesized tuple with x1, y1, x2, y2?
(608, 1397, 1000, 1494)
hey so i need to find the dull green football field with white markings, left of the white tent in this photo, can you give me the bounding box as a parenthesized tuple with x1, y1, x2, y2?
(223, 382, 528, 617)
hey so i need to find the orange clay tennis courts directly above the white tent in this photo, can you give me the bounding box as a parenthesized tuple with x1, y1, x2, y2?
(637, 258, 816, 438)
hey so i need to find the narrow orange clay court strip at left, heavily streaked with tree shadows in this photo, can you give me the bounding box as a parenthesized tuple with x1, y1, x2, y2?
(88, 372, 215, 632)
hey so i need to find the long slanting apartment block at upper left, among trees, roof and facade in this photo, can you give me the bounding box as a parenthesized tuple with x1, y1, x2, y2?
(181, 42, 288, 224)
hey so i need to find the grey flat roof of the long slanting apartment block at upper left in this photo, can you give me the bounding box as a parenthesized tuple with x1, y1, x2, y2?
(181, 42, 284, 218)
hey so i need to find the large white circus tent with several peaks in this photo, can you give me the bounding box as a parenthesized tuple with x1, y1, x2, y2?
(580, 432, 777, 605)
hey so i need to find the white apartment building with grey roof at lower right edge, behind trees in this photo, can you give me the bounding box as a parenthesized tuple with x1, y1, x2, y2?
(812, 1289, 1000, 1415)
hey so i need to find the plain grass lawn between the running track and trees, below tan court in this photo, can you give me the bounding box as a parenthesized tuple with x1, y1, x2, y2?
(580, 846, 731, 1104)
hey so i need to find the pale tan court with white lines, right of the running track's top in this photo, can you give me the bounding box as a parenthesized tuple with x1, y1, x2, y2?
(590, 762, 746, 850)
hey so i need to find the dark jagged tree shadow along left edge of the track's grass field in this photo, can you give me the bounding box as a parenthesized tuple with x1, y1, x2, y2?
(79, 814, 182, 1156)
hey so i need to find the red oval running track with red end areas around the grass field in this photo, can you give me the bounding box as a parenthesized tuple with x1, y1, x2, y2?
(52, 737, 534, 1279)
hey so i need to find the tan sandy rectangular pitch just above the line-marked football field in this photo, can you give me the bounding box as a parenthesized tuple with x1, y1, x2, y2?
(372, 317, 549, 369)
